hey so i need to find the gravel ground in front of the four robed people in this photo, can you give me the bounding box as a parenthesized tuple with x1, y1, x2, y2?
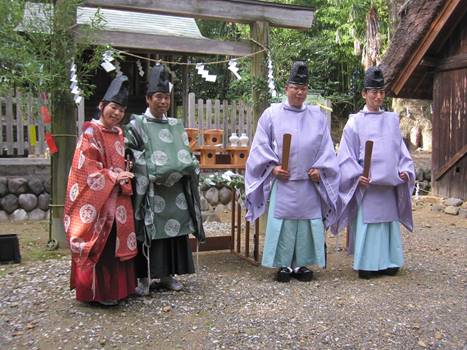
(0, 206, 467, 349)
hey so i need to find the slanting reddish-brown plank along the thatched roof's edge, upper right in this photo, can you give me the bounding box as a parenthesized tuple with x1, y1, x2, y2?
(391, 0, 462, 96)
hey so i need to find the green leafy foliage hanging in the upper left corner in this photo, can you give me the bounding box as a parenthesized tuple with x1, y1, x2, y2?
(0, 0, 104, 106)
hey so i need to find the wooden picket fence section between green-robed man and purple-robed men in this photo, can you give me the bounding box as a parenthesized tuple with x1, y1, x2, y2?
(185, 93, 255, 146)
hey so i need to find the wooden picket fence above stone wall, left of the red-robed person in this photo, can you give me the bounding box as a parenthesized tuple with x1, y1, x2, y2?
(0, 94, 84, 157)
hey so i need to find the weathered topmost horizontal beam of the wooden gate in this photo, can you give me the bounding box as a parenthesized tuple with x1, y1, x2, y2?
(84, 0, 314, 30)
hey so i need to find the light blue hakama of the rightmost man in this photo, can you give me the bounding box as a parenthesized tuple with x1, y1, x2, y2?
(351, 206, 404, 271)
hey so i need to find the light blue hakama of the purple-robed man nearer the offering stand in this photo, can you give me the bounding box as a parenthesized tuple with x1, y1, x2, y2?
(261, 183, 326, 268)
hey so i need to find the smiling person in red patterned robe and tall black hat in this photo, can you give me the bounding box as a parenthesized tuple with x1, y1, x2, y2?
(64, 75, 137, 305)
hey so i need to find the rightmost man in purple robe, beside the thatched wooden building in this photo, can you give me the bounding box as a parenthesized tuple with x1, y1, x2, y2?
(333, 67, 415, 279)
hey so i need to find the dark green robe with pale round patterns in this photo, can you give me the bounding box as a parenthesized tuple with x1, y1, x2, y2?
(125, 114, 205, 243)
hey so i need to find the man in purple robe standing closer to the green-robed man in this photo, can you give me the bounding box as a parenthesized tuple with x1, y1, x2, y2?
(245, 62, 339, 282)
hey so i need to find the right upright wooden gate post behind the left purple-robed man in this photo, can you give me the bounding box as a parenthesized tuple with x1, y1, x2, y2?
(250, 21, 269, 134)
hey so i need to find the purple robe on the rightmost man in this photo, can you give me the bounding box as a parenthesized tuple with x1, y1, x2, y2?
(332, 108, 415, 238)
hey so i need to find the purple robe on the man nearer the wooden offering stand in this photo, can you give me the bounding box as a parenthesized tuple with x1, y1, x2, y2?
(245, 103, 339, 227)
